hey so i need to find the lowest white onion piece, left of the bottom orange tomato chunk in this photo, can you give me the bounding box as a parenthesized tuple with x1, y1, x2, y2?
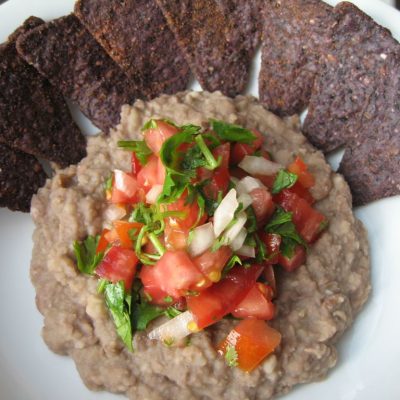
(148, 311, 194, 343)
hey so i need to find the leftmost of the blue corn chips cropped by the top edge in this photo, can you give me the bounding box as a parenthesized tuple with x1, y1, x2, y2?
(75, 0, 190, 99)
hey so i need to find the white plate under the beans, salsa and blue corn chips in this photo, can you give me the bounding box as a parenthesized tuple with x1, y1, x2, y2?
(0, 0, 400, 400)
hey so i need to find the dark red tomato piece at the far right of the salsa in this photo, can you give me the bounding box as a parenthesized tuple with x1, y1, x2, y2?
(274, 189, 327, 243)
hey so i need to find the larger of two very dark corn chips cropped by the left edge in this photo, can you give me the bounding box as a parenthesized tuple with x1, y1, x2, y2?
(0, 17, 86, 166)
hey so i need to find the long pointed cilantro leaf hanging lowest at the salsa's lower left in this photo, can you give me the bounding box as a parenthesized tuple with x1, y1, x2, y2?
(104, 281, 133, 351)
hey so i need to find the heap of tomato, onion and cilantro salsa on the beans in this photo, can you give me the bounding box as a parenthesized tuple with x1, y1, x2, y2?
(74, 119, 327, 372)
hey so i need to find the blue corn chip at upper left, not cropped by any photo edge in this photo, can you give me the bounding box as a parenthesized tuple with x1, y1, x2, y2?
(17, 14, 138, 133)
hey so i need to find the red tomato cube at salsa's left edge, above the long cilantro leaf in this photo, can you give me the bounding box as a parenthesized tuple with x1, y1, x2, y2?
(96, 246, 139, 291)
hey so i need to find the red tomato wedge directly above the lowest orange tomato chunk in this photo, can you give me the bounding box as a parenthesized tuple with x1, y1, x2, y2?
(232, 282, 275, 321)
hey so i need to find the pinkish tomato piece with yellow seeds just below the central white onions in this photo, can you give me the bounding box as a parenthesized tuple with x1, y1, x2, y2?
(193, 246, 232, 282)
